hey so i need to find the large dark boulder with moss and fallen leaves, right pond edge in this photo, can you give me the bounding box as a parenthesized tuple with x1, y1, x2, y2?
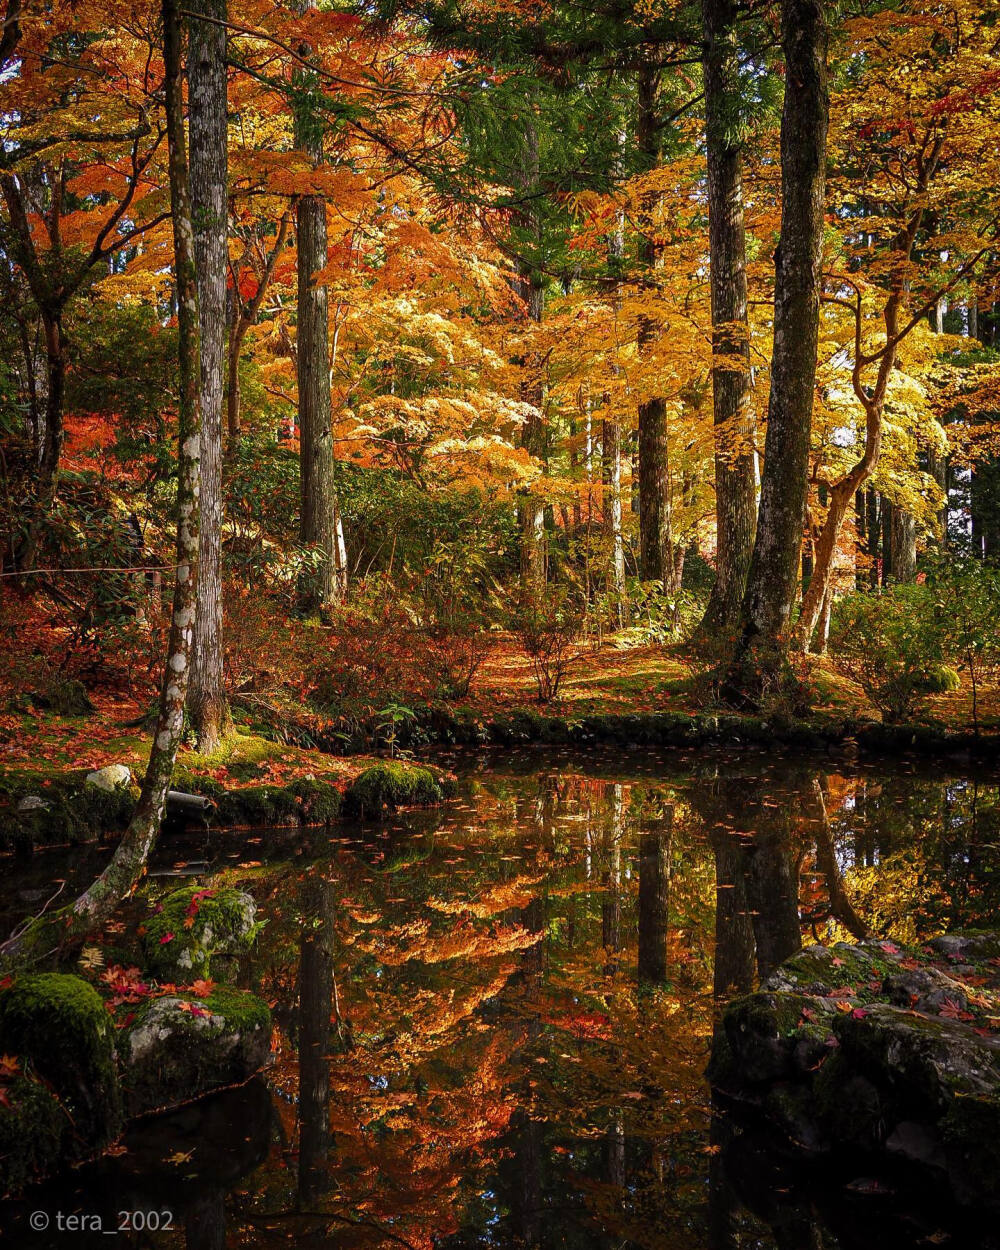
(709, 933, 1000, 1208)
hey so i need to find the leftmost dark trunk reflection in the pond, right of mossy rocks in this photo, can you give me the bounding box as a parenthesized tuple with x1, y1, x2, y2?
(299, 881, 334, 1206)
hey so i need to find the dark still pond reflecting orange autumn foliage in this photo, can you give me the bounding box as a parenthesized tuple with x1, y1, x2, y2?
(0, 751, 1000, 1250)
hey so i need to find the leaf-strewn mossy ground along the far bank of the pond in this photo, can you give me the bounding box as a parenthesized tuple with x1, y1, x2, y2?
(0, 639, 1000, 789)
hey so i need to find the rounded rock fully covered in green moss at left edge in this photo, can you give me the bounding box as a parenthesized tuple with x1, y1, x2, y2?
(0, 973, 123, 1153)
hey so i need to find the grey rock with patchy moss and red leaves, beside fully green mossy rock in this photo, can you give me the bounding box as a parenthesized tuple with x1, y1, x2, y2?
(119, 986, 271, 1115)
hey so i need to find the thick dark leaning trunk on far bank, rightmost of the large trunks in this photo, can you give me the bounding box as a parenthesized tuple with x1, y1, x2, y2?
(734, 0, 829, 685)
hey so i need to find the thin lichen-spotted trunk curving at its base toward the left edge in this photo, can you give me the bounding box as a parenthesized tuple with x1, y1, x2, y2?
(0, 0, 200, 968)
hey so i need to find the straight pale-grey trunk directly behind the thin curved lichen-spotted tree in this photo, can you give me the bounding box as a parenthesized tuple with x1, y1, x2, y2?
(188, 0, 233, 754)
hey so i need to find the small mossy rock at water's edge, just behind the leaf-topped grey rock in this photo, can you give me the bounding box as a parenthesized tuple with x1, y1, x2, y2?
(143, 885, 260, 981)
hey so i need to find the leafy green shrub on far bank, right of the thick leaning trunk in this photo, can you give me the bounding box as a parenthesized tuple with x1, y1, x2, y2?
(833, 585, 944, 724)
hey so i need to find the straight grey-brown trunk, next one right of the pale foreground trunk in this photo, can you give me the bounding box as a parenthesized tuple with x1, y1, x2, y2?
(295, 5, 348, 611)
